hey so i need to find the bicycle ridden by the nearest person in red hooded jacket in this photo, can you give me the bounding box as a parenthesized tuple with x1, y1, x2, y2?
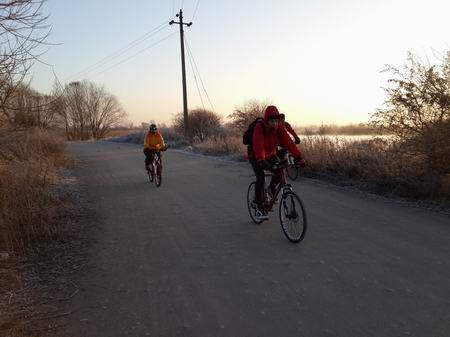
(247, 161, 308, 243)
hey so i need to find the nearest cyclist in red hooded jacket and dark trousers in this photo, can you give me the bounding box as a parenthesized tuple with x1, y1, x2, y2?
(249, 105, 305, 220)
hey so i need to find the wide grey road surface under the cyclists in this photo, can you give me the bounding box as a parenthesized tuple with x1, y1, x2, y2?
(57, 142, 450, 337)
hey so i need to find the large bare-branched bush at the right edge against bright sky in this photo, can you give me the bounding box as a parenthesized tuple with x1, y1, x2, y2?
(372, 52, 450, 197)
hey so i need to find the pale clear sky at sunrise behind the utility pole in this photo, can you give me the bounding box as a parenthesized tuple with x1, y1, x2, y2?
(32, 0, 450, 126)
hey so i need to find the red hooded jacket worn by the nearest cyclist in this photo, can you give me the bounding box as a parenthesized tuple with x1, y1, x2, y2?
(250, 105, 301, 160)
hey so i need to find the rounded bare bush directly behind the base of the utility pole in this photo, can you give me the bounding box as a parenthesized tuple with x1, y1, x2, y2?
(173, 108, 222, 142)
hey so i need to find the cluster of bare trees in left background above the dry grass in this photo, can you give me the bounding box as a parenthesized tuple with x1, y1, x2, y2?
(0, 80, 126, 140)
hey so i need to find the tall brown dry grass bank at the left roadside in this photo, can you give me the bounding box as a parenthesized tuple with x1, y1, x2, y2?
(0, 130, 68, 253)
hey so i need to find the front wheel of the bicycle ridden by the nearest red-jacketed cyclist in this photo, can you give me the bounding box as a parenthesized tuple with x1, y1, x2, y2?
(280, 191, 307, 243)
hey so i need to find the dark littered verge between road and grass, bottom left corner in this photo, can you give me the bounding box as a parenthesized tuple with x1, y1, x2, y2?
(0, 170, 98, 336)
